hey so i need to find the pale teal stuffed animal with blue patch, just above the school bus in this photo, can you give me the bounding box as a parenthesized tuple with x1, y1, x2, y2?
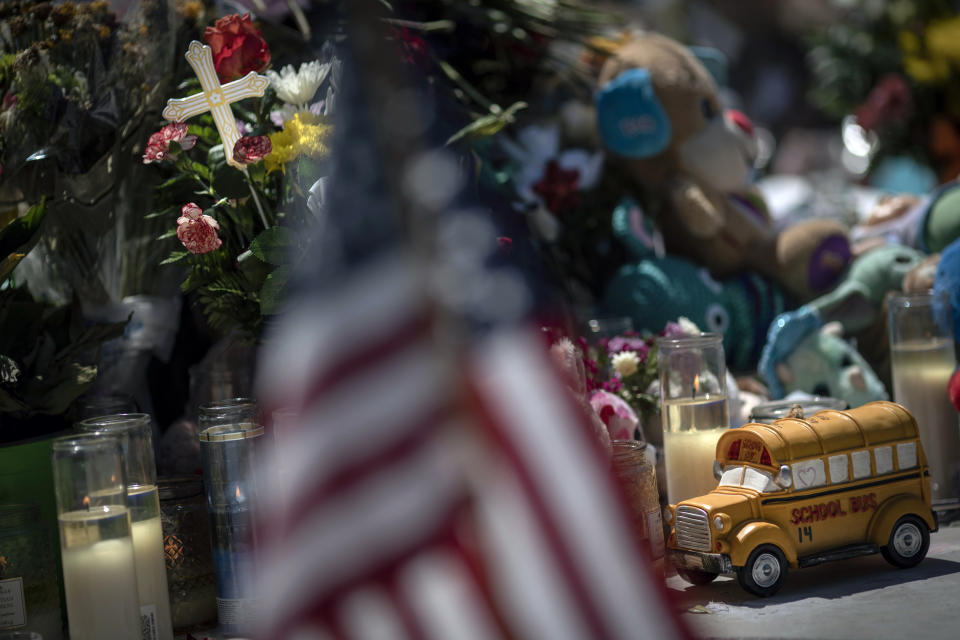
(758, 245, 924, 406)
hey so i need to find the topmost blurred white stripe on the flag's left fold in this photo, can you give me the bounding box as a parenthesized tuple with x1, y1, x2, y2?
(258, 254, 425, 401)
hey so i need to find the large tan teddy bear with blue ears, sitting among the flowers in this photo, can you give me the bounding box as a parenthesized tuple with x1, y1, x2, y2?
(596, 34, 850, 301)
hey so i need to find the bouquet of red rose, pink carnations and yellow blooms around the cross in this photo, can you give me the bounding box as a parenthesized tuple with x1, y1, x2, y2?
(142, 14, 341, 339)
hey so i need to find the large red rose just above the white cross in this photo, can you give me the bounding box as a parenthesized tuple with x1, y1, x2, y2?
(203, 13, 270, 82)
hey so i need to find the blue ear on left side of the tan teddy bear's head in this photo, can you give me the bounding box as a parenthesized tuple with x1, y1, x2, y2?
(595, 69, 670, 158)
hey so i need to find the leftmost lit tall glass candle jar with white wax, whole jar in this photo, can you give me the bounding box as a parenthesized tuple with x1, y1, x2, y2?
(52, 434, 141, 640)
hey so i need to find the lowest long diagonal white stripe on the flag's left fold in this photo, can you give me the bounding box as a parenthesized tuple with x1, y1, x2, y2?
(264, 427, 465, 620)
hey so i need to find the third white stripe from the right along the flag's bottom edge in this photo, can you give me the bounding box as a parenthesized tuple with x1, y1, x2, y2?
(400, 550, 500, 640)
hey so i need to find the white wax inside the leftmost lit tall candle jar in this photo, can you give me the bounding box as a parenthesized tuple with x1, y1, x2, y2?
(59, 507, 140, 640)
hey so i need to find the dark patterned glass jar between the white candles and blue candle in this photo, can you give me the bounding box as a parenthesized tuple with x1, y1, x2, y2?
(158, 476, 217, 629)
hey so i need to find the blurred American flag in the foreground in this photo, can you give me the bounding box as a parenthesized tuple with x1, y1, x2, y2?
(259, 3, 687, 640)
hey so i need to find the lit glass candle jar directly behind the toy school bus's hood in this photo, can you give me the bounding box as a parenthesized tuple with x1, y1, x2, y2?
(657, 333, 730, 504)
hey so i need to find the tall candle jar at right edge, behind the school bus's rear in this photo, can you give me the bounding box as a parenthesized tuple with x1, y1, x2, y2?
(887, 292, 960, 501)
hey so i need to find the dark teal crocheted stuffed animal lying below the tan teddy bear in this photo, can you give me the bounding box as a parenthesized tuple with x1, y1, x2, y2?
(603, 200, 786, 371)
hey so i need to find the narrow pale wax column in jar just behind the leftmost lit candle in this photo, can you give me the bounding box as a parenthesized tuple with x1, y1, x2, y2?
(128, 486, 173, 640)
